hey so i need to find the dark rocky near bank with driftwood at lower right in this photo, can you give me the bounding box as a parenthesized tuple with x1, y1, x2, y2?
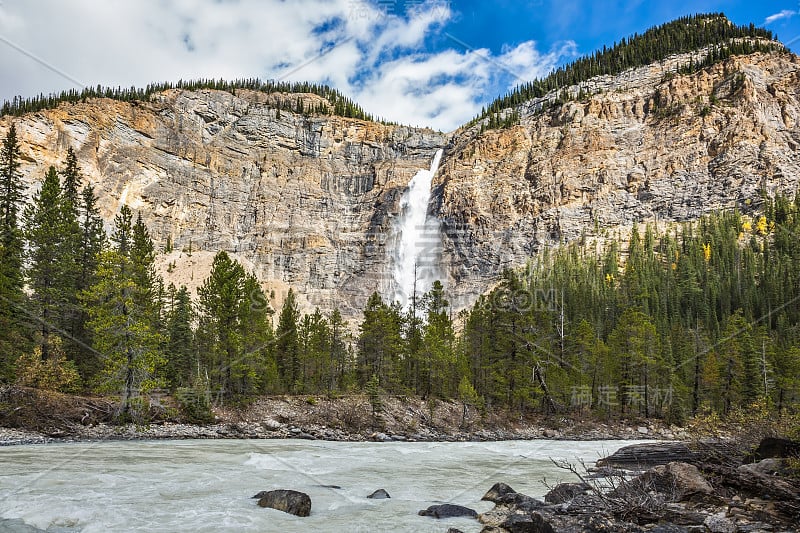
(478, 438, 800, 533)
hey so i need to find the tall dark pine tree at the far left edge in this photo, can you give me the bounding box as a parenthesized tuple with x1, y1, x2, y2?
(0, 123, 27, 377)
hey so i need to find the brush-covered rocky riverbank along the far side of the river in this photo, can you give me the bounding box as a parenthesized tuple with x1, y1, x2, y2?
(0, 387, 687, 445)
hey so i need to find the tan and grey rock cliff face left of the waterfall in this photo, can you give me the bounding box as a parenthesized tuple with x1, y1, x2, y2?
(0, 90, 445, 317)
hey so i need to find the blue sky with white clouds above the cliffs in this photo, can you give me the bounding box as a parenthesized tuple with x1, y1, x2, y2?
(0, 0, 800, 131)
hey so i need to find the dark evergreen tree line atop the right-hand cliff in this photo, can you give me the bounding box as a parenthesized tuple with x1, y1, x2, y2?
(470, 13, 786, 129)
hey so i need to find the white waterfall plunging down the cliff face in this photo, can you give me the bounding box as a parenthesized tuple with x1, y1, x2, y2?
(389, 150, 443, 308)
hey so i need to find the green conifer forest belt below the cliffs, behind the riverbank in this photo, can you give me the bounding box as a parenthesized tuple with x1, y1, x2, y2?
(0, 125, 800, 421)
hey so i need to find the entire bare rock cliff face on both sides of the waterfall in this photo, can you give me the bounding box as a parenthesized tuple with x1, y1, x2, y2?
(0, 48, 800, 319)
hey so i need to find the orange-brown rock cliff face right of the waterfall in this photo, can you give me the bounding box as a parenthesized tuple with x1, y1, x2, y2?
(436, 50, 800, 305)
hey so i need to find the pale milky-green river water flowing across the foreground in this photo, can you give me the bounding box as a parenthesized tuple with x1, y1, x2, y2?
(0, 440, 629, 533)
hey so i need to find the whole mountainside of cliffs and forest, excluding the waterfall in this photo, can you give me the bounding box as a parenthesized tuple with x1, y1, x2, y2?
(0, 14, 800, 420)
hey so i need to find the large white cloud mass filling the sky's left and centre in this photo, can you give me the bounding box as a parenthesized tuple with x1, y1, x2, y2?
(0, 0, 574, 130)
